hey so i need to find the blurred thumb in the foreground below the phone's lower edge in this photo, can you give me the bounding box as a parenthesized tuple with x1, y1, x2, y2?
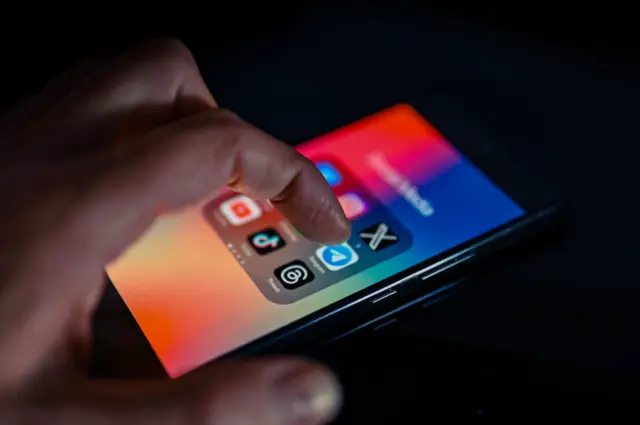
(41, 359, 341, 425)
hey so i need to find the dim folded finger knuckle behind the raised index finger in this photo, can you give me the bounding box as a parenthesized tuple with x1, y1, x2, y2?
(23, 39, 216, 155)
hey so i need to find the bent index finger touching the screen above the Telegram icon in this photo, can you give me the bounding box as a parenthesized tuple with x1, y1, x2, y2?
(71, 109, 350, 261)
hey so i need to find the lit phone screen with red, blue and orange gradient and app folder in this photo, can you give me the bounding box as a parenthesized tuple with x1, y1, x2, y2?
(107, 105, 525, 377)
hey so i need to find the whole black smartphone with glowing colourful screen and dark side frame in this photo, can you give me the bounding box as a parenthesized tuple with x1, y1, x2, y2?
(107, 104, 561, 377)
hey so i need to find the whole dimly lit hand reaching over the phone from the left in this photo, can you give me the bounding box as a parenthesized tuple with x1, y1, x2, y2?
(0, 40, 350, 425)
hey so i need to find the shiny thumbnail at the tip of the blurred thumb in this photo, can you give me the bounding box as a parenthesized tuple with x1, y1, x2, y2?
(277, 366, 342, 424)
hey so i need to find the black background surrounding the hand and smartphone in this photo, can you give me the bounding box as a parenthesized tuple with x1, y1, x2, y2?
(2, 0, 640, 422)
